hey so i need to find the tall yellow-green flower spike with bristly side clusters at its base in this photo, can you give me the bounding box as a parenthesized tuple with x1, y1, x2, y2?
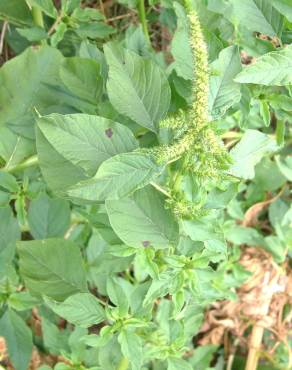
(156, 1, 231, 218)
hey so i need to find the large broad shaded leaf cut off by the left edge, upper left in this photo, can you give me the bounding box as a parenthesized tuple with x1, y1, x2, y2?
(0, 47, 77, 139)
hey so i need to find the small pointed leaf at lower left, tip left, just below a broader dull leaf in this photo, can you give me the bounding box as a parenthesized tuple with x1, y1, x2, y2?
(45, 292, 105, 328)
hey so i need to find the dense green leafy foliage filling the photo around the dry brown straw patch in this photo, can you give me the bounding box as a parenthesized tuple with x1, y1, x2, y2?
(0, 0, 292, 370)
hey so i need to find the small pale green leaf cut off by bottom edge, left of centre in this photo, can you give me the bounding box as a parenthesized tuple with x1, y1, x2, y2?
(118, 329, 143, 370)
